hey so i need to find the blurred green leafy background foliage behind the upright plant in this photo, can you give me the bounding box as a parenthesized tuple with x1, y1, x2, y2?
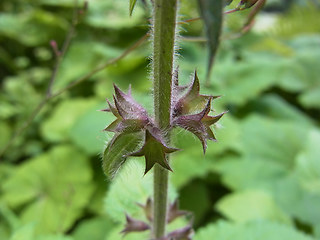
(0, 0, 320, 240)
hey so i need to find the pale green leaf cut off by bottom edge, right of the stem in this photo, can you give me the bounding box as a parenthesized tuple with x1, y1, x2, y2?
(193, 221, 314, 240)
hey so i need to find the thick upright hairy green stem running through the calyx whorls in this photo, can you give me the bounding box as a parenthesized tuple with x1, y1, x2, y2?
(153, 0, 177, 239)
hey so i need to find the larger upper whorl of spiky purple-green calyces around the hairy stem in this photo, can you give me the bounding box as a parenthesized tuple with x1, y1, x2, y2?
(103, 69, 224, 175)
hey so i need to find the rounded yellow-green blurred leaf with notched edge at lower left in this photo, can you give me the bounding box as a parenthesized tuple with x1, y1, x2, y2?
(2, 145, 94, 233)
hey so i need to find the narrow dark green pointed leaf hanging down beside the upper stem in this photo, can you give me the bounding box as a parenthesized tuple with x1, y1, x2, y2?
(198, 0, 224, 79)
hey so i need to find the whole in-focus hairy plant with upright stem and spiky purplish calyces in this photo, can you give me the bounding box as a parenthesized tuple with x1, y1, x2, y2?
(103, 0, 265, 240)
